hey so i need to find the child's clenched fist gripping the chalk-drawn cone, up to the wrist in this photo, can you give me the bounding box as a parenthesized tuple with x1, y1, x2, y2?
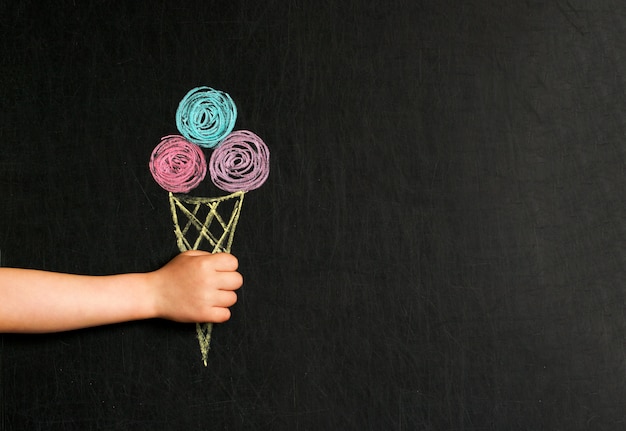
(149, 251, 243, 323)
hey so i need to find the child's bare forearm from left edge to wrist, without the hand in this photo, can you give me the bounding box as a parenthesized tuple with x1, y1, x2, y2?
(0, 268, 155, 333)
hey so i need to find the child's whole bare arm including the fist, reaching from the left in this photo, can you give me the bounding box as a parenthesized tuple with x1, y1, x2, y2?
(0, 251, 243, 333)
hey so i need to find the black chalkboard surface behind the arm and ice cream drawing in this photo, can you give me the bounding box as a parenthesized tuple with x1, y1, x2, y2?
(0, 0, 626, 430)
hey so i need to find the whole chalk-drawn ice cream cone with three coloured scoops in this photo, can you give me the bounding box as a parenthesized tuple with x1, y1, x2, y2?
(149, 87, 270, 366)
